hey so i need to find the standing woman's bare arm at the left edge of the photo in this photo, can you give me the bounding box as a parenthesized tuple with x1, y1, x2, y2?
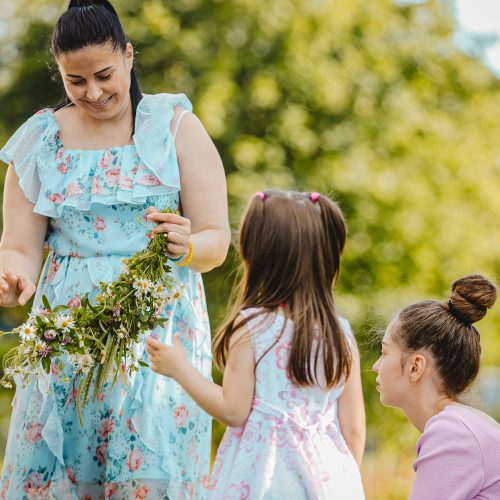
(0, 164, 48, 306)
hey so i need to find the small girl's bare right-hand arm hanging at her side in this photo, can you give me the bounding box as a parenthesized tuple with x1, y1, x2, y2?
(338, 337, 366, 465)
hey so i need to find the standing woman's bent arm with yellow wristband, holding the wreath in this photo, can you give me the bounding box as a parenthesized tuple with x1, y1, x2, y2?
(148, 109, 231, 272)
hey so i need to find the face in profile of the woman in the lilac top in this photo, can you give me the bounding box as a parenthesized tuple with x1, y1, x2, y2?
(373, 318, 411, 408)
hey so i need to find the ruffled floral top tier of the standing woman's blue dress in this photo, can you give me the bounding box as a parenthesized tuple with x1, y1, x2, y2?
(0, 94, 192, 219)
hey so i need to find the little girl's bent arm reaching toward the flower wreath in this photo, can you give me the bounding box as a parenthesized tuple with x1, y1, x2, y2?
(147, 327, 255, 427)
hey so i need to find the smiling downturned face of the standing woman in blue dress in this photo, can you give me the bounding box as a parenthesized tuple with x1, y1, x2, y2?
(57, 43, 134, 120)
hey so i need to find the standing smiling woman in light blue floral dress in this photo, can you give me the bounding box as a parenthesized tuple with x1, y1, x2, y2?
(0, 0, 230, 500)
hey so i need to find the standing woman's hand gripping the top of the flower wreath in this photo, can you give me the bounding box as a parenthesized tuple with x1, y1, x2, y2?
(146, 207, 191, 259)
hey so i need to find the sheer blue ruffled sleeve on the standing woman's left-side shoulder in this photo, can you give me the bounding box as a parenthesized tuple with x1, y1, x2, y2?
(0, 109, 57, 204)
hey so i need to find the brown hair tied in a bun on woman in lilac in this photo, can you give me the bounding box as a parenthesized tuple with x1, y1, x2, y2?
(393, 274, 497, 399)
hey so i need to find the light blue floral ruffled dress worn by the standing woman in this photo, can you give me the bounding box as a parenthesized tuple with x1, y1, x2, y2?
(0, 94, 211, 500)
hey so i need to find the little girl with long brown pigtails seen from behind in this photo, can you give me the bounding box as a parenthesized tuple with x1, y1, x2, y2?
(147, 191, 365, 500)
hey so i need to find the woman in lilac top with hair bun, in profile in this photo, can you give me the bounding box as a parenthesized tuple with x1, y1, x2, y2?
(373, 275, 500, 500)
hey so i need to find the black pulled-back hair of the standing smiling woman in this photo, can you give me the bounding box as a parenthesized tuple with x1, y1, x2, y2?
(51, 0, 142, 133)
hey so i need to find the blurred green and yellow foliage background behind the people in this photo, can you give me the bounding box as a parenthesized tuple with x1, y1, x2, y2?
(0, 0, 500, 500)
